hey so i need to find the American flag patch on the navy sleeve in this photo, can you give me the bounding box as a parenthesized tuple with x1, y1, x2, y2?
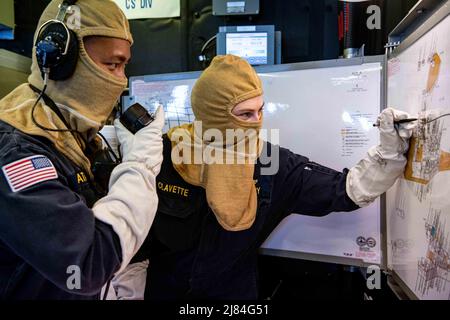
(2, 155, 58, 192)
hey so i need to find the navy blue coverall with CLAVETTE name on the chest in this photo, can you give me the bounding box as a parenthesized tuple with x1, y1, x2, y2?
(134, 137, 359, 299)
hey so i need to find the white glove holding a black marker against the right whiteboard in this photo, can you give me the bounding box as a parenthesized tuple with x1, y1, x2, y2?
(346, 108, 417, 207)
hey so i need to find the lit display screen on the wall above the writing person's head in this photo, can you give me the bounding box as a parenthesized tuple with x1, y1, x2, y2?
(226, 32, 267, 65)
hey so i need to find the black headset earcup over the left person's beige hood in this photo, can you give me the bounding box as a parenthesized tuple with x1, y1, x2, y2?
(35, 0, 79, 82)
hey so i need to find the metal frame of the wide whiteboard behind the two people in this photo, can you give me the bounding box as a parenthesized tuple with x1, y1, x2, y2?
(130, 55, 387, 268)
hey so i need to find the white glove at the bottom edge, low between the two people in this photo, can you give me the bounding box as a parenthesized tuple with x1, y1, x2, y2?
(106, 260, 149, 300)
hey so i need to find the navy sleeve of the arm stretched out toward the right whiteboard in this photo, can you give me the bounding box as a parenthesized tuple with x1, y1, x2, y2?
(277, 148, 359, 216)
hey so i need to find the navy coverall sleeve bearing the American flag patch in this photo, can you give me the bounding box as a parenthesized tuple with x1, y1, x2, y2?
(0, 145, 122, 295)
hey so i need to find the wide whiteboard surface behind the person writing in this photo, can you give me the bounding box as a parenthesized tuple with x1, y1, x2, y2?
(128, 56, 384, 265)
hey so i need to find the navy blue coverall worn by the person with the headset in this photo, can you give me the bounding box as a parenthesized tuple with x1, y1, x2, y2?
(0, 121, 122, 299)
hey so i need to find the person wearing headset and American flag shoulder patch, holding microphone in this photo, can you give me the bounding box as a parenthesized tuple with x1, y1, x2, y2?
(0, 0, 164, 300)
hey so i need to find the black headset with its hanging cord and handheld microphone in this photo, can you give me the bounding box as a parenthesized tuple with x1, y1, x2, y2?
(30, 0, 136, 210)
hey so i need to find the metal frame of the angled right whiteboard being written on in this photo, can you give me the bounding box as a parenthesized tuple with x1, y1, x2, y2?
(386, 0, 450, 300)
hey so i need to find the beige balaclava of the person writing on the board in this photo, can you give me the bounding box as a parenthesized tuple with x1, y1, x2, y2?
(168, 55, 263, 231)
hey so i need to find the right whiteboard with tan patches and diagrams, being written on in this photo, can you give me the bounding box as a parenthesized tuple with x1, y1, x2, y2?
(386, 10, 450, 300)
